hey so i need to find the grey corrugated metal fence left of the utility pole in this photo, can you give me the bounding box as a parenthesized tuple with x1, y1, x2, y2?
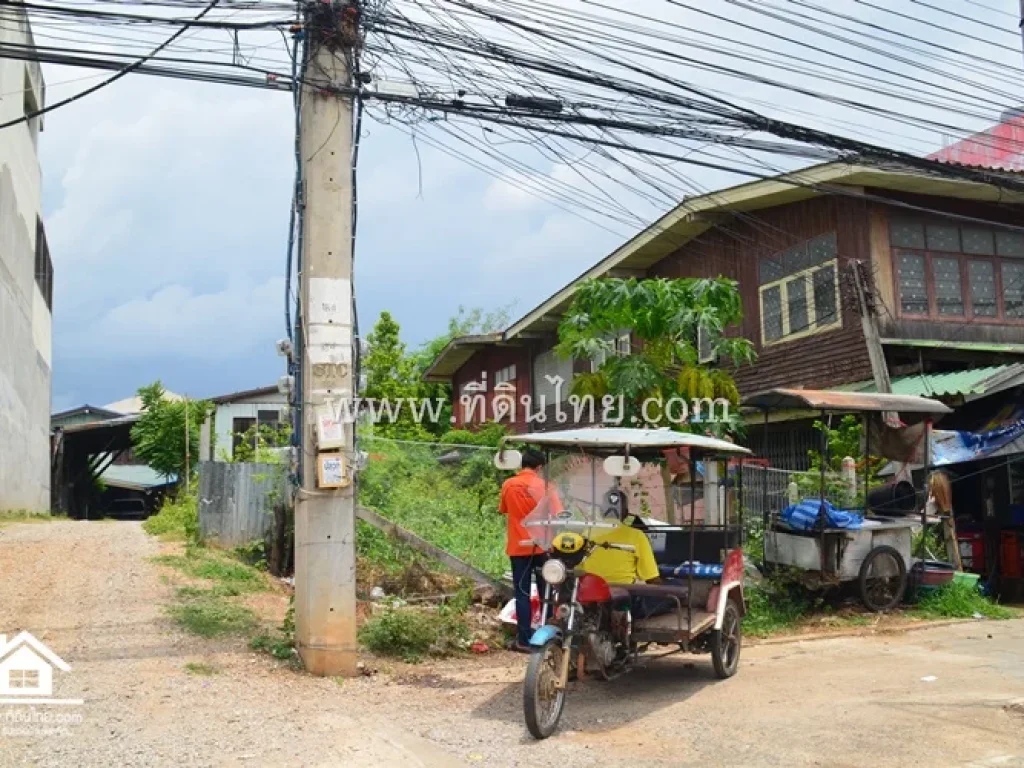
(199, 462, 288, 547)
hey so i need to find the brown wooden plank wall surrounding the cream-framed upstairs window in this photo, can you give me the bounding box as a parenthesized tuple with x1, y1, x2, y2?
(649, 198, 871, 394)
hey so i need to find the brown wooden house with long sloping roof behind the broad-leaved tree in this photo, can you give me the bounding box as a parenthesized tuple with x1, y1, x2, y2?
(427, 163, 1024, 460)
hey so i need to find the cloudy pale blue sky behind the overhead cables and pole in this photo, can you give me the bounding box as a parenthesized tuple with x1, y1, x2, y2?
(34, 0, 1020, 411)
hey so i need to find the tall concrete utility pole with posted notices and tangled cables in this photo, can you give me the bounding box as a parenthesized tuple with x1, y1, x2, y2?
(295, 0, 358, 676)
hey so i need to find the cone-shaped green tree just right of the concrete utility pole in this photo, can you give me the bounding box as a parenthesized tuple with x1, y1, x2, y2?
(362, 311, 425, 439)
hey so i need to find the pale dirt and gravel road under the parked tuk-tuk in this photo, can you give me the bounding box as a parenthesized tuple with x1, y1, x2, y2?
(0, 522, 1024, 768)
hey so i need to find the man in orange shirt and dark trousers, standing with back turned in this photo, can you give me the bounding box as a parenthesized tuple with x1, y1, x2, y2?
(498, 449, 562, 653)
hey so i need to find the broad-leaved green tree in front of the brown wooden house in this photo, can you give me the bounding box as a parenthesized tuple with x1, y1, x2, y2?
(558, 278, 754, 432)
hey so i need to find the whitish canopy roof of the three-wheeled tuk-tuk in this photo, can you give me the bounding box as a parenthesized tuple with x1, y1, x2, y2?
(505, 427, 751, 456)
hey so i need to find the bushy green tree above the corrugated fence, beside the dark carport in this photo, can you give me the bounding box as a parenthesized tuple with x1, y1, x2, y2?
(131, 381, 213, 478)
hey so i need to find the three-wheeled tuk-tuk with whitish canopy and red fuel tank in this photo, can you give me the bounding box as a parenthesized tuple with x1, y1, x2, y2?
(495, 428, 750, 738)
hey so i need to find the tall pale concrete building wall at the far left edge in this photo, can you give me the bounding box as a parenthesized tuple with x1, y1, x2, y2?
(0, 8, 52, 511)
